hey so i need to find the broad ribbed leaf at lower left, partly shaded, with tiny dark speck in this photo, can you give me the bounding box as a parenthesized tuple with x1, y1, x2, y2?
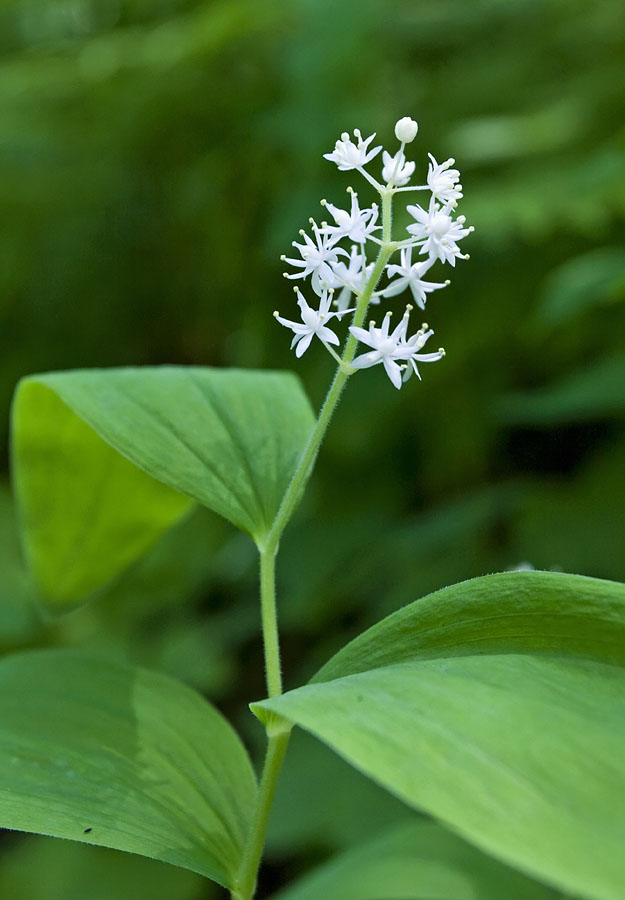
(0, 650, 256, 887)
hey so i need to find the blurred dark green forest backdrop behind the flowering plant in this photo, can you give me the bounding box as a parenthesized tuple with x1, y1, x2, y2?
(0, 0, 625, 900)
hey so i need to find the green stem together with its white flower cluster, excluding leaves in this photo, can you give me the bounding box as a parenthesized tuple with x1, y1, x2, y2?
(231, 117, 472, 900)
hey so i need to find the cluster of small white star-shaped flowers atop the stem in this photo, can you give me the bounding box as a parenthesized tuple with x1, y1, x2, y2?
(274, 117, 473, 388)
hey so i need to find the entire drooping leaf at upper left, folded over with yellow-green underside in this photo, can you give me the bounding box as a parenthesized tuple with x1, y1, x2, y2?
(14, 366, 314, 609)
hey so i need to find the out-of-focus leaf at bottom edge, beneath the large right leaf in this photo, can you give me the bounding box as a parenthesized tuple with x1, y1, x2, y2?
(274, 819, 557, 900)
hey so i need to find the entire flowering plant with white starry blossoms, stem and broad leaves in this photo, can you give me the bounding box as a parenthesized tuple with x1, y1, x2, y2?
(0, 118, 625, 900)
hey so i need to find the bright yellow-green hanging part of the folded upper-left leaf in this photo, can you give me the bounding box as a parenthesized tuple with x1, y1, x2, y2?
(13, 373, 190, 612)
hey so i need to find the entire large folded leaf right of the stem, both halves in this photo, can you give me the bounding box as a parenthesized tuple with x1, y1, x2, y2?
(253, 572, 625, 900)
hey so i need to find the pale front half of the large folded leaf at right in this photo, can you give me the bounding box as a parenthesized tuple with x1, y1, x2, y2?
(261, 655, 625, 900)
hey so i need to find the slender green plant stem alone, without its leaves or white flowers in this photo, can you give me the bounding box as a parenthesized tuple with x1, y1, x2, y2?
(231, 190, 397, 900)
